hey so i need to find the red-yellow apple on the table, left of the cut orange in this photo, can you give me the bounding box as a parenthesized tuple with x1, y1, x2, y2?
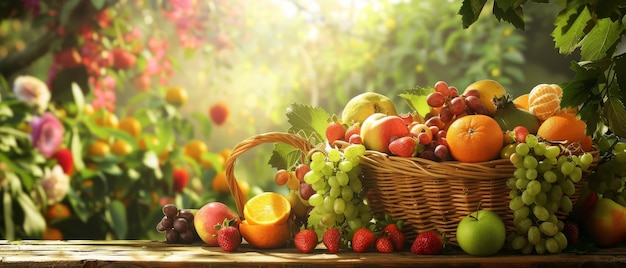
(193, 202, 241, 246)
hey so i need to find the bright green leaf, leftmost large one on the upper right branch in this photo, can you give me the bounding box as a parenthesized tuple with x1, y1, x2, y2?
(552, 6, 591, 55)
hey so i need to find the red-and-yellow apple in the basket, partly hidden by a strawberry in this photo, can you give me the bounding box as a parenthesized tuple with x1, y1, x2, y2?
(361, 113, 409, 153)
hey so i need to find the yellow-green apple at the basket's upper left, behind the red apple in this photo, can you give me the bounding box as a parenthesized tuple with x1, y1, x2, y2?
(341, 92, 398, 125)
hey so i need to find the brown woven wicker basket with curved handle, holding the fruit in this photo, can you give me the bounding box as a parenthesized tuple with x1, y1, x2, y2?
(225, 132, 599, 244)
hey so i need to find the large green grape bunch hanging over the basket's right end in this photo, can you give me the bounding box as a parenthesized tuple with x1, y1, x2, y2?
(506, 134, 593, 254)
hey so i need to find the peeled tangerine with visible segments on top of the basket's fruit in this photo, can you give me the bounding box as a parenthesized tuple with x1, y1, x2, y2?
(528, 84, 563, 121)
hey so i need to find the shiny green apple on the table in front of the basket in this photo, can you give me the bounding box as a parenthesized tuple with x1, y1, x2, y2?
(456, 210, 506, 256)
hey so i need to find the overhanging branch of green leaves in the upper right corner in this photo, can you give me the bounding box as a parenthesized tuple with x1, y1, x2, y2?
(459, 0, 626, 139)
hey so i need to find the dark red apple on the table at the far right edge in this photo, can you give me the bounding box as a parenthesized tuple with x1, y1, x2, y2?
(585, 198, 626, 247)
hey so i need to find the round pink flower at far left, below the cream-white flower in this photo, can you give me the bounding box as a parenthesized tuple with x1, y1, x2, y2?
(30, 112, 63, 158)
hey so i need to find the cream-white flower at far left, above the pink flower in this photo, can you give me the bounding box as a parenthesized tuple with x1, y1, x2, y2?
(13, 75, 50, 113)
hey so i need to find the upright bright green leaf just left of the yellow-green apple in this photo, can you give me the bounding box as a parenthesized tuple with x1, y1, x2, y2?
(287, 103, 330, 144)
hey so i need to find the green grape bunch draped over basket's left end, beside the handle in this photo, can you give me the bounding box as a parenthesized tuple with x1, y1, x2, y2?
(304, 144, 372, 238)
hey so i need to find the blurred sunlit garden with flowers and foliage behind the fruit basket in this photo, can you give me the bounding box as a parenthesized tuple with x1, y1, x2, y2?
(0, 0, 624, 239)
